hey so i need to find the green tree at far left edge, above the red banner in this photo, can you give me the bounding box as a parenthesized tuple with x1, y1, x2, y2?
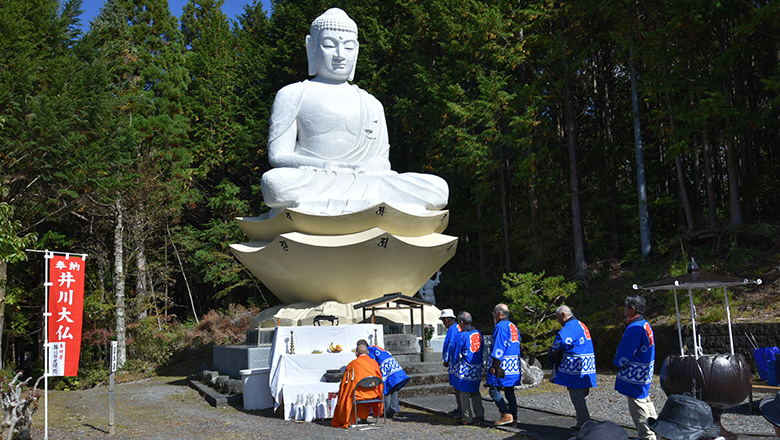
(0, 0, 90, 364)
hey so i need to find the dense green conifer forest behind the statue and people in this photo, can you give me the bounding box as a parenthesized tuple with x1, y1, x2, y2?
(0, 0, 780, 386)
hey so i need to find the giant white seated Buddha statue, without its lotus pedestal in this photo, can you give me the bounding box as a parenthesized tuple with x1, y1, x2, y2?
(261, 8, 449, 216)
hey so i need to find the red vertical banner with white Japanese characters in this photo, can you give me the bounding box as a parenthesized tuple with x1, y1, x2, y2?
(48, 255, 86, 376)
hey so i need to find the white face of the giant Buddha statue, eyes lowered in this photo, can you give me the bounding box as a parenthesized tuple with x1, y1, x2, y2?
(306, 29, 358, 82)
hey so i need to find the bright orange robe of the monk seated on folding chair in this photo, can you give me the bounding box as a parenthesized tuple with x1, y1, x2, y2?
(330, 354, 383, 428)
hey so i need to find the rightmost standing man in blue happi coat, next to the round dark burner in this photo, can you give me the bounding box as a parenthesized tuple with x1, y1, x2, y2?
(613, 296, 658, 440)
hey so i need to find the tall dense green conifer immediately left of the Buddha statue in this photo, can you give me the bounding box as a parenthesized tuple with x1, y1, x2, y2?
(174, 1, 272, 304)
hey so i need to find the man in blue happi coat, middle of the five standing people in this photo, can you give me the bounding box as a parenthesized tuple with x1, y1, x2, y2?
(486, 304, 521, 426)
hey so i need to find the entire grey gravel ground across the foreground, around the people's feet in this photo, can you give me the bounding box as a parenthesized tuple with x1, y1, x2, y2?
(32, 375, 773, 440)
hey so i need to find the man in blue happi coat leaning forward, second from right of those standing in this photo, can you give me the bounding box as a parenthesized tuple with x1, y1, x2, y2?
(550, 305, 596, 431)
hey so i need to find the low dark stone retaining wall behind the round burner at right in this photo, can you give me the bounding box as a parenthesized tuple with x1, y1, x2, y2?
(590, 322, 780, 373)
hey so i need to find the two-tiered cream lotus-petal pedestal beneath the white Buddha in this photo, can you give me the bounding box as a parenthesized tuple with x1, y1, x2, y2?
(230, 203, 458, 304)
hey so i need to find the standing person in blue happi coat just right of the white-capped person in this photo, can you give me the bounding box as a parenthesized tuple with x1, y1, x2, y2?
(450, 312, 485, 425)
